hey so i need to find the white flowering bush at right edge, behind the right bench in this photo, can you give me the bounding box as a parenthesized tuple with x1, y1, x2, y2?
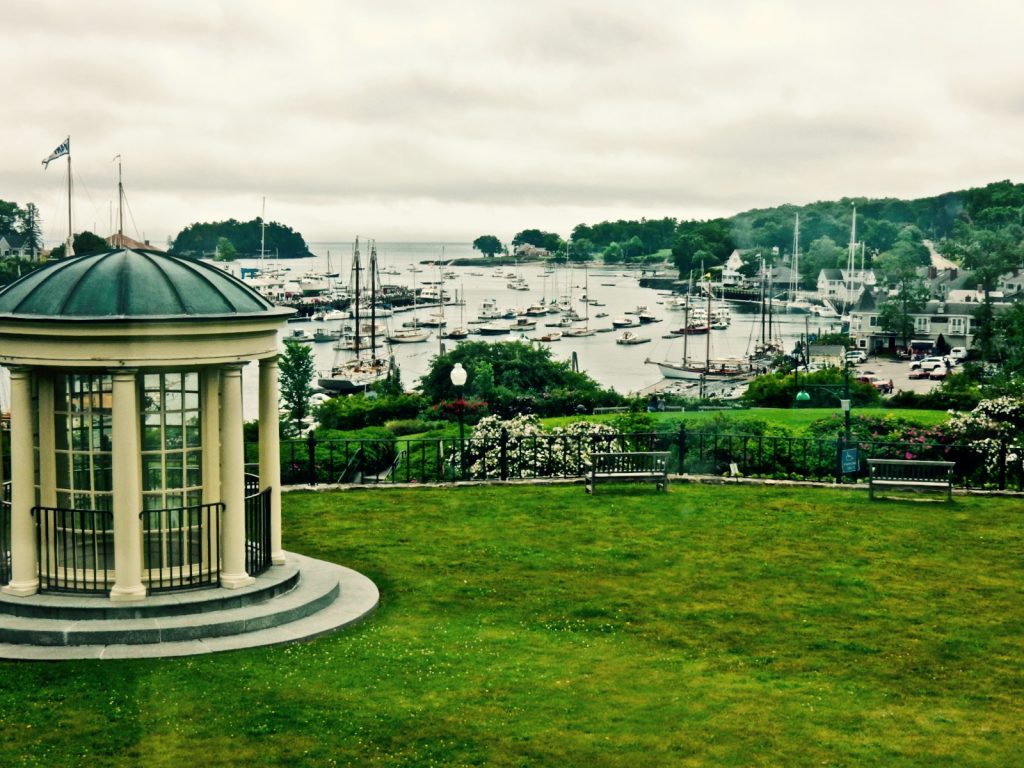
(946, 396, 1024, 483)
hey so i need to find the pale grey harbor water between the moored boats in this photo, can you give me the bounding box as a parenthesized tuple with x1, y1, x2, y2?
(229, 243, 836, 419)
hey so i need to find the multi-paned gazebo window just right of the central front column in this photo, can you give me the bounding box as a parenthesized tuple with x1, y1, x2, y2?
(141, 372, 203, 568)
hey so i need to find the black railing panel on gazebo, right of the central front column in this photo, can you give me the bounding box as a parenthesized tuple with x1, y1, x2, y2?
(139, 502, 224, 593)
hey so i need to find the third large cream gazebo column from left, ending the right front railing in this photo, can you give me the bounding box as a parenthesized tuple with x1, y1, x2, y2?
(220, 366, 256, 589)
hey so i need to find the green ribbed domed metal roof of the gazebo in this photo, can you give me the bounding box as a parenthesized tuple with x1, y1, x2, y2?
(0, 249, 291, 319)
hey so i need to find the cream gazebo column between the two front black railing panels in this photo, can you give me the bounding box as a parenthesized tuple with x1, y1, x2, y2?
(111, 370, 145, 601)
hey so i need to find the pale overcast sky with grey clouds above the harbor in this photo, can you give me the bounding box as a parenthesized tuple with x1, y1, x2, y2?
(0, 0, 1024, 244)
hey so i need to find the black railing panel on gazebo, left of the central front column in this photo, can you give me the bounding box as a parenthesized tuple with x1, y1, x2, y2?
(32, 507, 114, 593)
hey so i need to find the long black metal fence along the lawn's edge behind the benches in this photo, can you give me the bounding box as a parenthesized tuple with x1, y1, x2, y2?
(262, 426, 1024, 490)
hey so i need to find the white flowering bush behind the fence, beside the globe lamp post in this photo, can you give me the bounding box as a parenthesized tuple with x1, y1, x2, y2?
(468, 414, 623, 479)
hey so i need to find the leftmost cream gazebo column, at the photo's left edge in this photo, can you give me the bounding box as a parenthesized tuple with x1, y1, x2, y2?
(3, 368, 39, 597)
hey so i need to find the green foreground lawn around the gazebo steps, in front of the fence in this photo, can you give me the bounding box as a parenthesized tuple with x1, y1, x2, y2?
(0, 485, 1024, 768)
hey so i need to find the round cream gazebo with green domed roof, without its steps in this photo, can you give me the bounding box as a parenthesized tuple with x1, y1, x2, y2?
(0, 249, 292, 602)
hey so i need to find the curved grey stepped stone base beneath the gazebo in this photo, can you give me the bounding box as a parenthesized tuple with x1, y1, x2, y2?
(0, 553, 380, 660)
